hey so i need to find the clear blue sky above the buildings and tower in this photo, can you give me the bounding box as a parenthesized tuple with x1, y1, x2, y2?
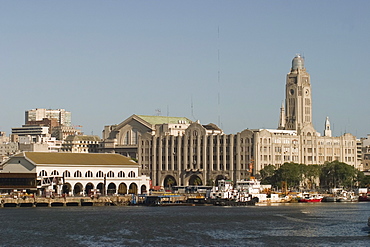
(0, 0, 370, 138)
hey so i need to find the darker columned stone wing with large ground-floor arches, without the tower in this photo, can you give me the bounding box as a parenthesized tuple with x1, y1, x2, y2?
(138, 122, 252, 187)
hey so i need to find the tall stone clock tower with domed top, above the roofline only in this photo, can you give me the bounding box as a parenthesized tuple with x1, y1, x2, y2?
(285, 55, 312, 131)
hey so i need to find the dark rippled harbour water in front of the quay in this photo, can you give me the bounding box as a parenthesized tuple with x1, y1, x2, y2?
(0, 203, 370, 246)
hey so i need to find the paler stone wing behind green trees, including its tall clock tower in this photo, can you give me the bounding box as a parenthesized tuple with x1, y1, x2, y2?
(240, 55, 360, 174)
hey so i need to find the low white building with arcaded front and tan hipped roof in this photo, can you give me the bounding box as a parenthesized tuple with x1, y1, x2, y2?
(0, 152, 149, 196)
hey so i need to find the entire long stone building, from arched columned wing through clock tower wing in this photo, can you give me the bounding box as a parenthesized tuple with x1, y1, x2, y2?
(138, 56, 359, 187)
